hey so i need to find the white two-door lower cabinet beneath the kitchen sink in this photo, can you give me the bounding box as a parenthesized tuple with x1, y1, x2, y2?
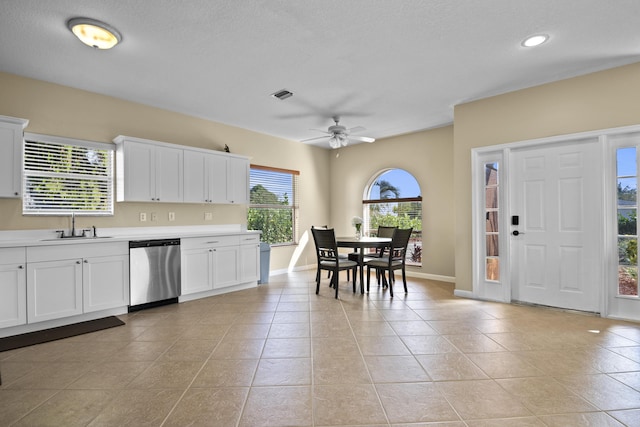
(26, 243, 129, 323)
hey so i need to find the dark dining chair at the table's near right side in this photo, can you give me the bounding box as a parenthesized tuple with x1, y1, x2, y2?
(365, 228, 413, 298)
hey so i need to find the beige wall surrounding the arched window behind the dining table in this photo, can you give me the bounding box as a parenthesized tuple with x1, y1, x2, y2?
(330, 126, 454, 277)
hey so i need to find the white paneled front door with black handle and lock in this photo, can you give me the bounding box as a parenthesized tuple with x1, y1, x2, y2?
(509, 138, 603, 312)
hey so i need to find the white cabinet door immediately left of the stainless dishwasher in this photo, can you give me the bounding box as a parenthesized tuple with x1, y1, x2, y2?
(82, 255, 129, 313)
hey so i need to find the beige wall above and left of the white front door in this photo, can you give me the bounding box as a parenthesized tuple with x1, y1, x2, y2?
(453, 64, 640, 290)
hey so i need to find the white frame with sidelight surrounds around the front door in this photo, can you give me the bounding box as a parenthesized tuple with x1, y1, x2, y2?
(471, 125, 640, 320)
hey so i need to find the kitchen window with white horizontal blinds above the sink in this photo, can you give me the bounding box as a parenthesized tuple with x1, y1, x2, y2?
(22, 133, 114, 215)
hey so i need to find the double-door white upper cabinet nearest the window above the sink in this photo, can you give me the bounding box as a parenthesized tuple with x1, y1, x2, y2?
(114, 136, 184, 203)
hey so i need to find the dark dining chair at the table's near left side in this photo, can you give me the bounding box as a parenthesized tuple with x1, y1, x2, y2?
(311, 228, 358, 299)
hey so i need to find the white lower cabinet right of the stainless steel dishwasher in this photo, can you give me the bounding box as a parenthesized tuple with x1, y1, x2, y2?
(181, 234, 260, 295)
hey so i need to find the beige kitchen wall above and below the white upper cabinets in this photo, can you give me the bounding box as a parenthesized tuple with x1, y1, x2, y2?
(0, 73, 329, 270)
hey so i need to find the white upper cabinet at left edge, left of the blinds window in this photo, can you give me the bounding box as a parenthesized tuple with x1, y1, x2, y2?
(0, 116, 29, 197)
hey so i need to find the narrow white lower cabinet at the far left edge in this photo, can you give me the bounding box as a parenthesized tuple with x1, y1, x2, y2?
(0, 247, 27, 328)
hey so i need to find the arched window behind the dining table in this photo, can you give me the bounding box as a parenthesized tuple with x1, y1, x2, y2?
(362, 169, 422, 265)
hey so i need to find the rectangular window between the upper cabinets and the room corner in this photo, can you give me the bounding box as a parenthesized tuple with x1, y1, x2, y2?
(247, 165, 300, 245)
